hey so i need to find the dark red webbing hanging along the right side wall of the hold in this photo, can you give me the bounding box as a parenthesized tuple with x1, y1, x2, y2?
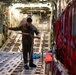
(56, 0, 76, 75)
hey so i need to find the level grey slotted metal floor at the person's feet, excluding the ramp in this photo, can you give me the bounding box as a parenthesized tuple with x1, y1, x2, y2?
(0, 52, 44, 75)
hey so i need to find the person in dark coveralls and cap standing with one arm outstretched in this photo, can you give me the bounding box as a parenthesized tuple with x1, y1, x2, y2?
(8, 17, 40, 69)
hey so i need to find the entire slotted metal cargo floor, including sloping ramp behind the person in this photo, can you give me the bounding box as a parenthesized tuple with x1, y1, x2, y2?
(0, 33, 49, 75)
